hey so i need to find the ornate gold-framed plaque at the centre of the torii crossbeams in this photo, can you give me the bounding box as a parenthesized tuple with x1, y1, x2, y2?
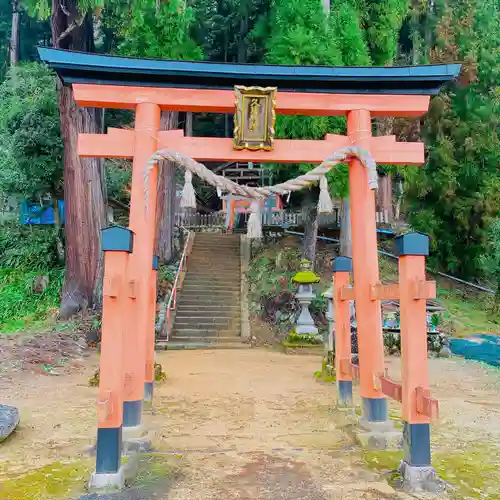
(234, 85, 277, 151)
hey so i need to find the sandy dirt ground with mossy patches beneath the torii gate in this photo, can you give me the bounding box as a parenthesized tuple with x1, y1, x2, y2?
(0, 348, 500, 500)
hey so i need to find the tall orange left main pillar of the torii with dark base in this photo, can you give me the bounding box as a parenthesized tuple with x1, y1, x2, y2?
(123, 102, 161, 436)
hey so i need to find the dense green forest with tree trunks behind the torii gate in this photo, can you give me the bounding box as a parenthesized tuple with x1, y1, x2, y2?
(0, 0, 500, 325)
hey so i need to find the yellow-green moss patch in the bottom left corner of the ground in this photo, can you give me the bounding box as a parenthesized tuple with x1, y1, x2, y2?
(0, 459, 92, 500)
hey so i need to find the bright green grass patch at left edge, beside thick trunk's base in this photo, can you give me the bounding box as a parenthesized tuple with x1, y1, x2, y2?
(0, 269, 64, 333)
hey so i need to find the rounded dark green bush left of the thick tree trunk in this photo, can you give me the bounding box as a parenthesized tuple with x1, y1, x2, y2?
(0, 63, 63, 198)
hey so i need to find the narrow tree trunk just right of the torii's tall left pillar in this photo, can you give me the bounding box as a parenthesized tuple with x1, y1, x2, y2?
(155, 111, 179, 262)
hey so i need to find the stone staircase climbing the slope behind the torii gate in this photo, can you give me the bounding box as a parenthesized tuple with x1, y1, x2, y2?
(168, 233, 247, 349)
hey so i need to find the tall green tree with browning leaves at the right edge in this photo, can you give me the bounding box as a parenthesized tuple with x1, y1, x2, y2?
(407, 0, 500, 277)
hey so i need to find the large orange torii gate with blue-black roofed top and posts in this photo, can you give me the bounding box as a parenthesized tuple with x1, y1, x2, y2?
(39, 48, 459, 492)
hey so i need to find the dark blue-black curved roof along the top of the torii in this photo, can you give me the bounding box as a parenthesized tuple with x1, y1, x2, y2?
(38, 47, 460, 95)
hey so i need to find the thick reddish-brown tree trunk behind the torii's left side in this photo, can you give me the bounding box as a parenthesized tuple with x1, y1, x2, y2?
(51, 0, 106, 318)
